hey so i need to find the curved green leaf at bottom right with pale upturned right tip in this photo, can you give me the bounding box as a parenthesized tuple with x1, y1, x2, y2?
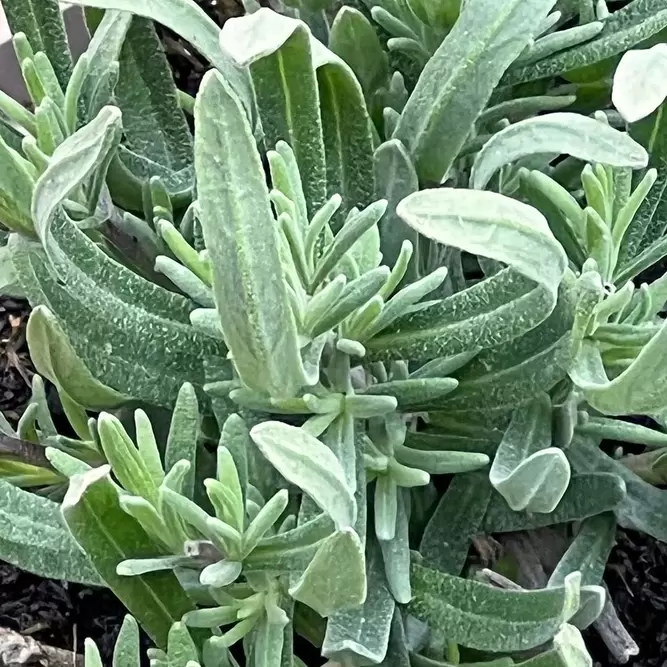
(408, 565, 581, 652)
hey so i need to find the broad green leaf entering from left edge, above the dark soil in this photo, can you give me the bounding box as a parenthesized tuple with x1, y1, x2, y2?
(0, 480, 101, 586)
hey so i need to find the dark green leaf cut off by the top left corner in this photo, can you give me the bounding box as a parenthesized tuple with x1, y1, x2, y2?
(2, 0, 72, 90)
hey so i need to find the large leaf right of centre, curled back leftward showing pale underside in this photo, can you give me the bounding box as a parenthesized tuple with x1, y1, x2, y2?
(365, 188, 567, 361)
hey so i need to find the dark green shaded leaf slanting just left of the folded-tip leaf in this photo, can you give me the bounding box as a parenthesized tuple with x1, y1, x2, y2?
(419, 473, 492, 576)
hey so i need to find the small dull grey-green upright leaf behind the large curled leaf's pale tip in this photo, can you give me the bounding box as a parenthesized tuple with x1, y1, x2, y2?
(373, 139, 419, 282)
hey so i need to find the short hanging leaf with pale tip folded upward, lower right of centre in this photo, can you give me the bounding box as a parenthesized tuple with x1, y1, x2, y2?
(489, 394, 571, 513)
